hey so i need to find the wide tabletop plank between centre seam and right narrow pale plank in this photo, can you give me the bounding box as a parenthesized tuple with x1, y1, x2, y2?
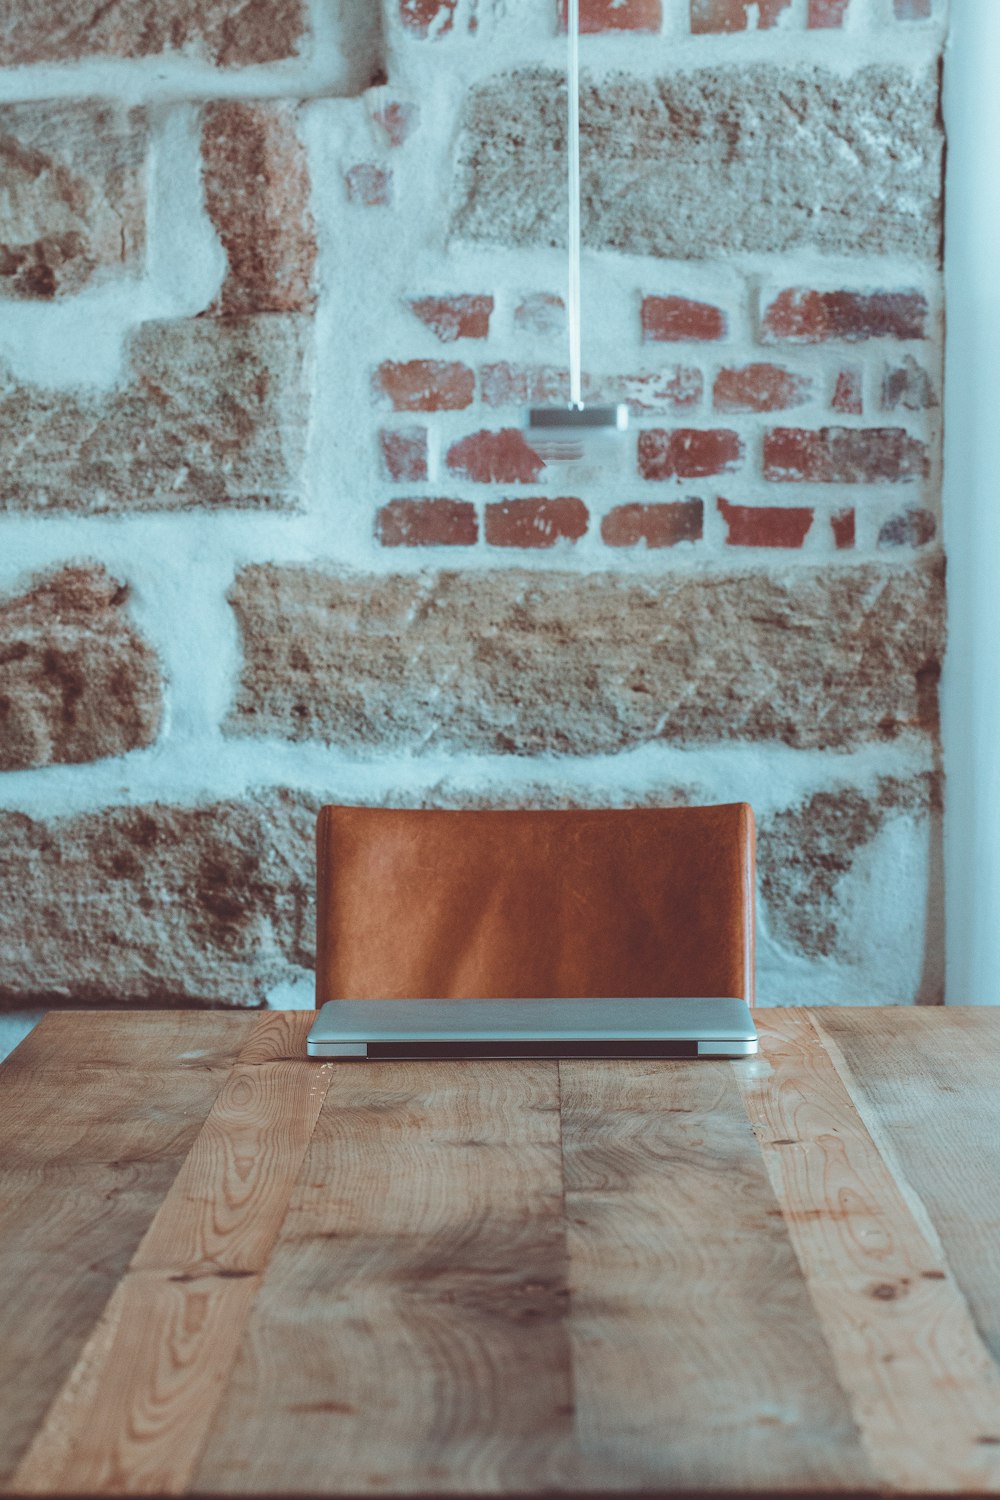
(561, 1062, 870, 1493)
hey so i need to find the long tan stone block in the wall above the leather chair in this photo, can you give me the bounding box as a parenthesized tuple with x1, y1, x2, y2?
(226, 558, 945, 756)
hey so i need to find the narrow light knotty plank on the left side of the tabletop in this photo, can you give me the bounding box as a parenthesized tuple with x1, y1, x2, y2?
(15, 1013, 331, 1494)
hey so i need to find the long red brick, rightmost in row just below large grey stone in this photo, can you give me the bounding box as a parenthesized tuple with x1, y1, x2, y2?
(760, 287, 928, 344)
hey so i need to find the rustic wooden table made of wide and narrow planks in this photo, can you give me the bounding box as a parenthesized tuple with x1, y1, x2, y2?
(0, 1008, 1000, 1496)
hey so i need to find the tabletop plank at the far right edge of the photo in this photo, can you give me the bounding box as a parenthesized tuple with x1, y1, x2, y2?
(813, 1005, 1000, 1374)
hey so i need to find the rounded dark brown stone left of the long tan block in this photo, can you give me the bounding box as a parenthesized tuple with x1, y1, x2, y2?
(0, 567, 162, 771)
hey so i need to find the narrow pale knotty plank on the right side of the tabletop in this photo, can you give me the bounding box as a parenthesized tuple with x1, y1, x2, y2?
(735, 1011, 1000, 1493)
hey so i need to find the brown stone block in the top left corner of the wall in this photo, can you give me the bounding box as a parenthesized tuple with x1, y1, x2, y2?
(0, 0, 309, 68)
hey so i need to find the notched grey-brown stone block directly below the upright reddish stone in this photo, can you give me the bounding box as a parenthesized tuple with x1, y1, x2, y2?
(0, 314, 312, 515)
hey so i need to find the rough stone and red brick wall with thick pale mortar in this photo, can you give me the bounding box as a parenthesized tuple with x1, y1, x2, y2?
(0, 0, 946, 1008)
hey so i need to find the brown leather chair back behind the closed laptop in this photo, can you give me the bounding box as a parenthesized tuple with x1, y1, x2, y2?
(316, 803, 754, 1005)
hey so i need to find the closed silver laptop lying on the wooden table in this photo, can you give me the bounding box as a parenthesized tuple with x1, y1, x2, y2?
(306, 999, 757, 1062)
